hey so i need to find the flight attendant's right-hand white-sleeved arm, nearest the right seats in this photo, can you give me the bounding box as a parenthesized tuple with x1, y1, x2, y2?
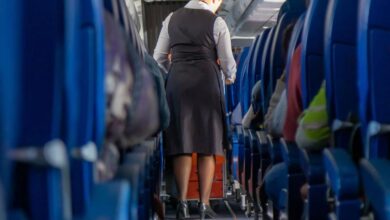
(214, 17, 237, 83)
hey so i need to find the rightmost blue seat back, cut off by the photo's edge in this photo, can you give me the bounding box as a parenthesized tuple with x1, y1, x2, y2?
(358, 0, 390, 158)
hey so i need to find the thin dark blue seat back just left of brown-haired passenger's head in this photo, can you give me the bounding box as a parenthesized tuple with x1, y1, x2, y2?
(261, 27, 275, 111)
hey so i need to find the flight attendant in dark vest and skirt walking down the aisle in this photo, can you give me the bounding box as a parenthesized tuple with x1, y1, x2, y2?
(154, 0, 236, 219)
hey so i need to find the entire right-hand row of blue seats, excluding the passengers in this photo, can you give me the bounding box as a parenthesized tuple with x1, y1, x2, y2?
(228, 0, 390, 219)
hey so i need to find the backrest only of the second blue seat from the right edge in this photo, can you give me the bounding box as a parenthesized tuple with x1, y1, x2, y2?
(324, 0, 358, 124)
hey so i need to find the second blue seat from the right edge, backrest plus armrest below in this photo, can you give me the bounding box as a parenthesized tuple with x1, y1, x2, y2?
(323, 0, 361, 219)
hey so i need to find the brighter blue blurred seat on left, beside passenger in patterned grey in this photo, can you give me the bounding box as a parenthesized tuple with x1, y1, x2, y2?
(64, 0, 105, 217)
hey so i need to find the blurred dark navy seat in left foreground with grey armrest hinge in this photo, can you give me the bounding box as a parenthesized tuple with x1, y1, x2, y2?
(7, 0, 72, 220)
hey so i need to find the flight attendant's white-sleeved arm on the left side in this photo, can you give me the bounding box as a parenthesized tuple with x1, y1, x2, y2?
(153, 13, 172, 70)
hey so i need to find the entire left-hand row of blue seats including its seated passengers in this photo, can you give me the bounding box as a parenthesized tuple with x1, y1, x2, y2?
(0, 0, 169, 220)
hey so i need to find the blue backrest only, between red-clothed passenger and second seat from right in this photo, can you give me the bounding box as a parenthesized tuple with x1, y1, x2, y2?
(301, 0, 328, 109)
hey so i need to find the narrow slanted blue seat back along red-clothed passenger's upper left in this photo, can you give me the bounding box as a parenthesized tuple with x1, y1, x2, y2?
(286, 13, 306, 87)
